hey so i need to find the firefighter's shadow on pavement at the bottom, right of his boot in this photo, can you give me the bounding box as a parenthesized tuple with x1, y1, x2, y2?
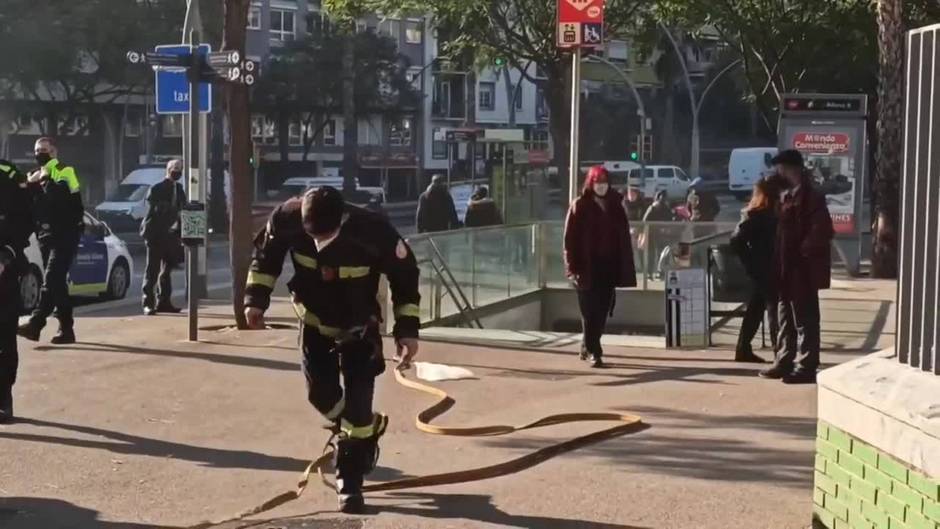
(370, 493, 650, 529)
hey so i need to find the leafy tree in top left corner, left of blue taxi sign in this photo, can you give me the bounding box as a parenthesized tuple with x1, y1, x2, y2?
(0, 0, 185, 175)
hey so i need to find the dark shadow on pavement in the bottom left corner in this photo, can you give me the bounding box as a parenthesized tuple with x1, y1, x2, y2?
(0, 497, 159, 529)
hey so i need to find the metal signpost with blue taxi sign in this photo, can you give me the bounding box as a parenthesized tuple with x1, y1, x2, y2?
(127, 45, 258, 342)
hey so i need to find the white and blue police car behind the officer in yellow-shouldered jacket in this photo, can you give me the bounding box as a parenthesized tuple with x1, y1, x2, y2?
(20, 212, 134, 312)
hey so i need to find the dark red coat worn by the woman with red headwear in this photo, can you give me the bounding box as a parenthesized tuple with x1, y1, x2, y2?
(565, 191, 636, 288)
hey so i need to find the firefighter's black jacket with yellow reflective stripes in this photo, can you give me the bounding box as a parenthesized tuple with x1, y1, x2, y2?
(245, 198, 420, 338)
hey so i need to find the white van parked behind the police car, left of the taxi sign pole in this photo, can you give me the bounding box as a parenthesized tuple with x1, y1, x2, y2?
(95, 165, 230, 233)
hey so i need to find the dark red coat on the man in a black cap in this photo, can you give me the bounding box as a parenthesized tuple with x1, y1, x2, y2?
(774, 183, 835, 300)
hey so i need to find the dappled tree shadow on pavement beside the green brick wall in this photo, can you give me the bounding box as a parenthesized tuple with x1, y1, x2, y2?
(478, 406, 816, 490)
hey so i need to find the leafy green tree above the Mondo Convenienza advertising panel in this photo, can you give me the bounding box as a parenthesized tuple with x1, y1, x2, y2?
(652, 0, 877, 130)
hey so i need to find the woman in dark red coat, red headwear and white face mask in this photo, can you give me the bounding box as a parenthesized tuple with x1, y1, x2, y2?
(564, 165, 636, 368)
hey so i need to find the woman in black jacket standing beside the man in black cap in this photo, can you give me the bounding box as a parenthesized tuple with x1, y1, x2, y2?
(730, 179, 780, 363)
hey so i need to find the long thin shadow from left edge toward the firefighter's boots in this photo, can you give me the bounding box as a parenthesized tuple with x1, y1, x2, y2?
(0, 418, 309, 473)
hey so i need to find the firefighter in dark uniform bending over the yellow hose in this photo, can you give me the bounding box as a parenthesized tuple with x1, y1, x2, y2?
(245, 187, 420, 513)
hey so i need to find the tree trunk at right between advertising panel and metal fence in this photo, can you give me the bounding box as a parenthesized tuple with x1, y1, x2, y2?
(872, 0, 904, 278)
